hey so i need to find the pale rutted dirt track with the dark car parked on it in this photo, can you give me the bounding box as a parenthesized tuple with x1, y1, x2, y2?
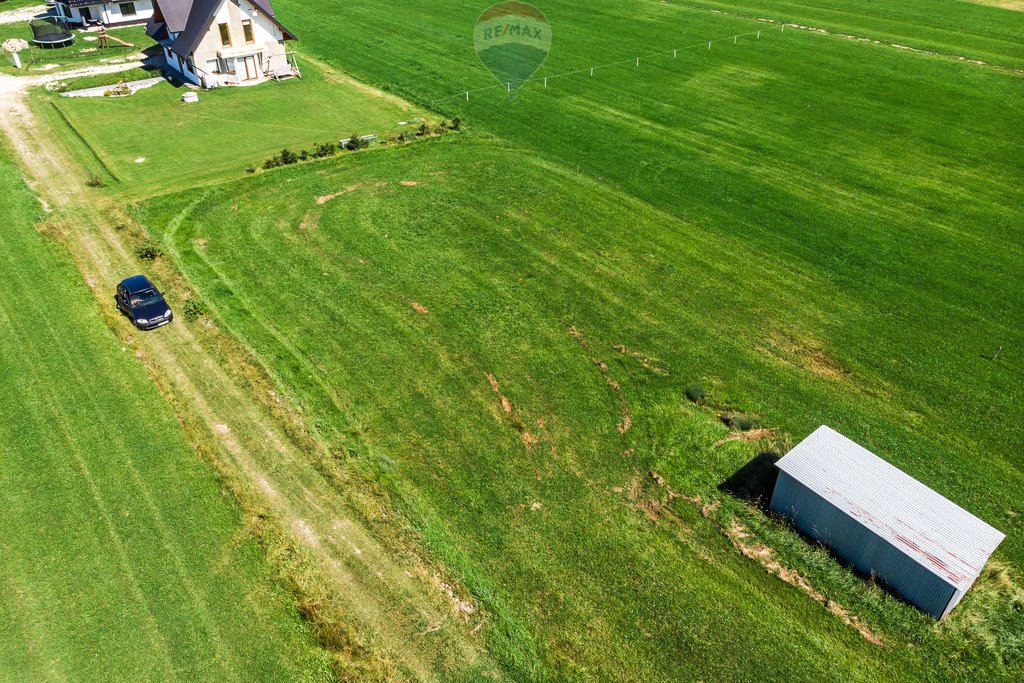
(0, 63, 485, 680)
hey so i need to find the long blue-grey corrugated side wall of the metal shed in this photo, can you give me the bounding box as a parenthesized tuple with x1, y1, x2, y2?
(771, 472, 955, 618)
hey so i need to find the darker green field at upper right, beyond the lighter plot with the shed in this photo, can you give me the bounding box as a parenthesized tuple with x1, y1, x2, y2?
(282, 0, 1024, 507)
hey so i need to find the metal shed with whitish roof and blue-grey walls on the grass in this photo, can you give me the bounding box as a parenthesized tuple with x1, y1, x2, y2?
(771, 426, 1006, 618)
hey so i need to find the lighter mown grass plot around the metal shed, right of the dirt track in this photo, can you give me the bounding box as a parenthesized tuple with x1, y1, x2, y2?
(139, 134, 1024, 681)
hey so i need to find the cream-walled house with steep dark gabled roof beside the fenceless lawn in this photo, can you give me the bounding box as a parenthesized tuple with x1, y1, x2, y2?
(145, 0, 299, 88)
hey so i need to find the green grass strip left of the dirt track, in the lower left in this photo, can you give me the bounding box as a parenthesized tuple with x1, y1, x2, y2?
(0, 152, 330, 681)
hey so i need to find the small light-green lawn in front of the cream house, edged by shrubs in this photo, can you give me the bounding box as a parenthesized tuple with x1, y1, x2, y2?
(43, 55, 424, 199)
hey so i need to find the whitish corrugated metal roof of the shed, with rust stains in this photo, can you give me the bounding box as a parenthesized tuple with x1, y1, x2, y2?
(776, 426, 1006, 591)
